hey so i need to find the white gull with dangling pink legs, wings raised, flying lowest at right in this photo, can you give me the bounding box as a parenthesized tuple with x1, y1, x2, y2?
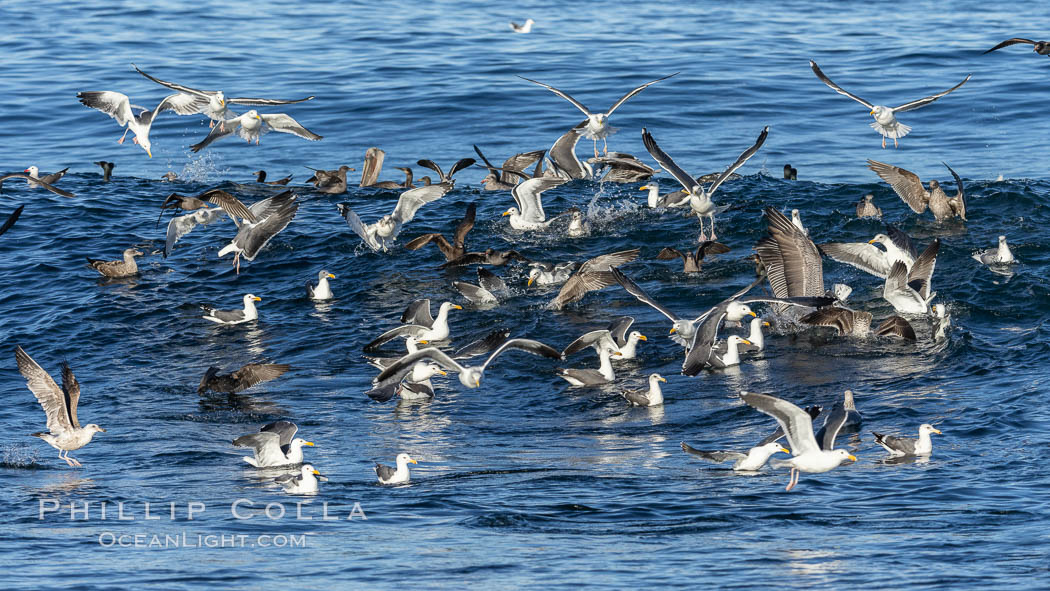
(740, 392, 857, 490)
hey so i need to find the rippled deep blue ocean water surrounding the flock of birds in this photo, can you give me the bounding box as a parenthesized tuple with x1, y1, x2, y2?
(0, 1, 1050, 589)
